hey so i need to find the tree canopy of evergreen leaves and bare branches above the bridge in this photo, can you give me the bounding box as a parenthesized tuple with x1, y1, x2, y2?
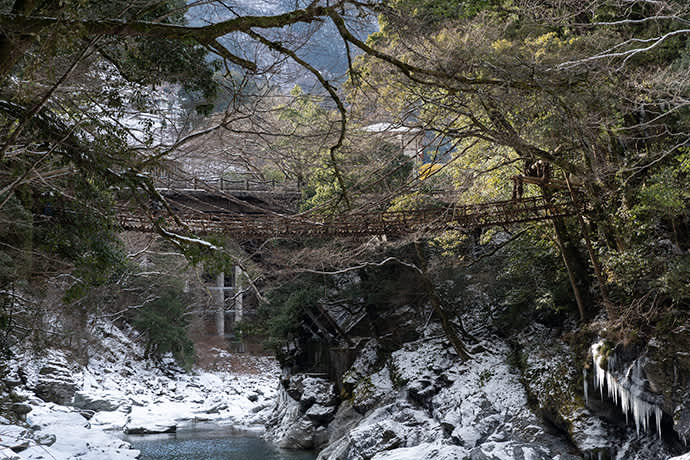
(0, 0, 690, 348)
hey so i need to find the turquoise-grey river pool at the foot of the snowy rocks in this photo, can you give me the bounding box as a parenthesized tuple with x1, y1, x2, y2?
(127, 429, 316, 460)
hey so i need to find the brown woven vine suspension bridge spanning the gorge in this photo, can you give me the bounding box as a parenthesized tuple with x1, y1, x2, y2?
(118, 197, 577, 239)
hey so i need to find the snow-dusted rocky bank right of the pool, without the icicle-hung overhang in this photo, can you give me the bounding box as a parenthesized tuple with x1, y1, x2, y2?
(269, 325, 688, 460)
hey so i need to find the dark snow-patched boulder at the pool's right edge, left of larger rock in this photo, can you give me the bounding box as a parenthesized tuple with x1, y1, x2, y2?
(267, 374, 338, 449)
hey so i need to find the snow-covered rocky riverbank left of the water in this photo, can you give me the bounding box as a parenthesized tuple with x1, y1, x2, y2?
(0, 323, 280, 460)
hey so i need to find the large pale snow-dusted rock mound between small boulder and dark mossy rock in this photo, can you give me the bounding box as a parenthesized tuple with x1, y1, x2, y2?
(298, 336, 580, 460)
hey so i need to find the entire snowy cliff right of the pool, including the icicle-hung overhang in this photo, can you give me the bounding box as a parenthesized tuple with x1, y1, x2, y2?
(268, 268, 690, 460)
